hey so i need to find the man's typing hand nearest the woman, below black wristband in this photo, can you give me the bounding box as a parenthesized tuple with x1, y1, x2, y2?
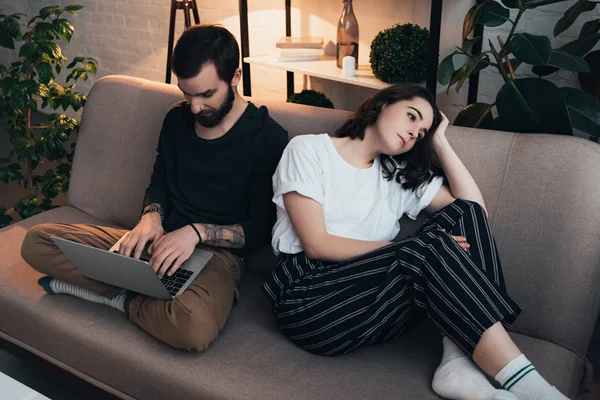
(148, 225, 198, 278)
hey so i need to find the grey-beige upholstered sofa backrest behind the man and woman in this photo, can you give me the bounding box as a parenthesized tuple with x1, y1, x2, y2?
(69, 76, 600, 354)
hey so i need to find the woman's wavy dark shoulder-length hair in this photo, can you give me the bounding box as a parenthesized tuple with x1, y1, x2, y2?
(335, 83, 444, 190)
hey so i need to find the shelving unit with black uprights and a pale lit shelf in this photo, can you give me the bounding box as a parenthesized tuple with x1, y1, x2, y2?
(239, 0, 443, 96)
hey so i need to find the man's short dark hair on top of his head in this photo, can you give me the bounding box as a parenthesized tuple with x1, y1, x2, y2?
(171, 25, 240, 83)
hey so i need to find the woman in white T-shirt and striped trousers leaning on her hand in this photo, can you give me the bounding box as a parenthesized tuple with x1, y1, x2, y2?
(263, 84, 566, 400)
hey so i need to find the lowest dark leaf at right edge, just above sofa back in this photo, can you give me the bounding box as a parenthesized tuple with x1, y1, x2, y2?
(560, 87, 600, 137)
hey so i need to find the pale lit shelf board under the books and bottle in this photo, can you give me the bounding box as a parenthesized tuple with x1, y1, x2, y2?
(243, 56, 445, 93)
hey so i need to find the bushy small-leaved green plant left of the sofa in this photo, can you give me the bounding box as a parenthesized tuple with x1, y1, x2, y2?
(0, 5, 97, 227)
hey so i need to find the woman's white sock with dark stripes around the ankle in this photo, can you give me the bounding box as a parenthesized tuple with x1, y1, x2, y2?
(496, 354, 568, 400)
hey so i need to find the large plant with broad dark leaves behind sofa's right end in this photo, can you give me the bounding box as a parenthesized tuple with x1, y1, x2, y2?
(438, 0, 600, 140)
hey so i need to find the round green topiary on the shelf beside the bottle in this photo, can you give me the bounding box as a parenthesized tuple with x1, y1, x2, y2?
(369, 24, 429, 83)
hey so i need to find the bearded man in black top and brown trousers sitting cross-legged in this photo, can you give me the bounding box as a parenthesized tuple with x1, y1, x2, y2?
(21, 25, 287, 350)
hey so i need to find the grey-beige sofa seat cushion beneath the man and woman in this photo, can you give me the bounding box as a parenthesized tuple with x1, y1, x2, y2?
(0, 207, 585, 400)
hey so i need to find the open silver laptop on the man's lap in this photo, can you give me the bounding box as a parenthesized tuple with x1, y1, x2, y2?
(51, 236, 213, 300)
